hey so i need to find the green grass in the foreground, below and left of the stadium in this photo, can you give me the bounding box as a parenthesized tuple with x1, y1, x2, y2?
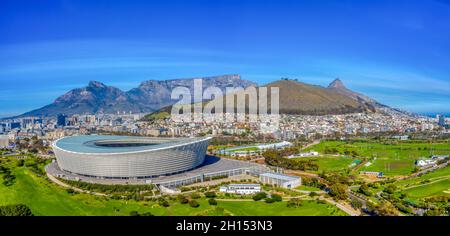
(0, 160, 344, 216)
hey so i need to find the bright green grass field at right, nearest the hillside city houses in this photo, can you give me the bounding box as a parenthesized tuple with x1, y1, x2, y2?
(306, 141, 450, 176)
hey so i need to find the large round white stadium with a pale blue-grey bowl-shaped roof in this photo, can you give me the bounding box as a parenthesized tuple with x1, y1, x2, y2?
(53, 135, 211, 179)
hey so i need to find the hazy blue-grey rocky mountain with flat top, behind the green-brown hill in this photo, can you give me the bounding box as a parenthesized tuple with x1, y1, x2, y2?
(18, 75, 256, 117)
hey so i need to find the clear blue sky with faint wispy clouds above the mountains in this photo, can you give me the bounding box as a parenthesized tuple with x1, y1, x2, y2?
(0, 0, 450, 117)
